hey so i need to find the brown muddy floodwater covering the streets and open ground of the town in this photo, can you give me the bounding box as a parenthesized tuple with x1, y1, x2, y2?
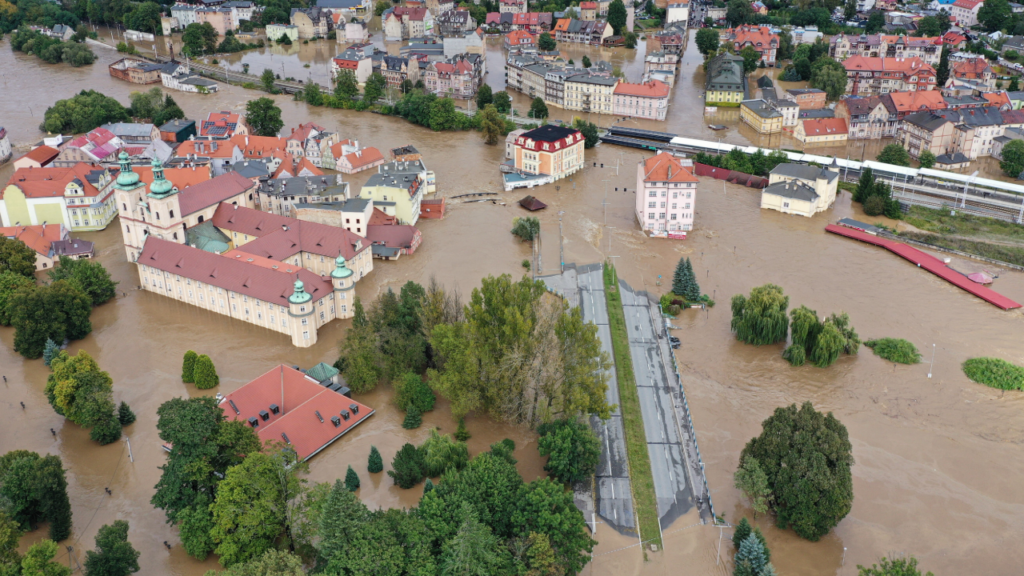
(0, 29, 1024, 576)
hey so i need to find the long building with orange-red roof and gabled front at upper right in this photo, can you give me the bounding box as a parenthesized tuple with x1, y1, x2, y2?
(843, 55, 935, 96)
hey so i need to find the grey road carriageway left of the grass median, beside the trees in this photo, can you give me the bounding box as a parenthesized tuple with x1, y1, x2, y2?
(540, 264, 636, 533)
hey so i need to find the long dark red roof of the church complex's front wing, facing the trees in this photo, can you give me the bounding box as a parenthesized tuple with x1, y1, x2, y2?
(137, 236, 334, 306)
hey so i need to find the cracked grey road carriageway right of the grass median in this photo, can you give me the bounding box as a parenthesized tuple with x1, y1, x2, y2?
(618, 281, 694, 530)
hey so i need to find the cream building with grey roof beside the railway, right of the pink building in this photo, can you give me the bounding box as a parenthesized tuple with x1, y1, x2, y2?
(761, 162, 839, 217)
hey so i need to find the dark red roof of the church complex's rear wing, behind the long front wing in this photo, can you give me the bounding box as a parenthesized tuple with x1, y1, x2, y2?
(212, 204, 369, 261)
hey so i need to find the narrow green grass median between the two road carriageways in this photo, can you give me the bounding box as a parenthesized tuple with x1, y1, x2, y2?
(604, 264, 662, 549)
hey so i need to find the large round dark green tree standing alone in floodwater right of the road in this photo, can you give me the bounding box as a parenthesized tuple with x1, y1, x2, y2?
(740, 402, 853, 541)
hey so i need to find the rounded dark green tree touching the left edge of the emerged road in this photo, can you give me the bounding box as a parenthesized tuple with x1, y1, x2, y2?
(537, 414, 601, 484)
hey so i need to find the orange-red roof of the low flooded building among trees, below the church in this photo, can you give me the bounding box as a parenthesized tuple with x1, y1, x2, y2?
(220, 364, 374, 460)
